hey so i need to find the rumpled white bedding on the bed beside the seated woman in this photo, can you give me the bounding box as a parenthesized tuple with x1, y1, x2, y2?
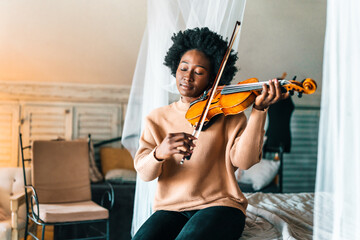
(240, 192, 314, 240)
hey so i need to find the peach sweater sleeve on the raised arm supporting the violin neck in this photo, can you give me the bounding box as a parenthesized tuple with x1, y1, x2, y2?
(230, 108, 267, 170)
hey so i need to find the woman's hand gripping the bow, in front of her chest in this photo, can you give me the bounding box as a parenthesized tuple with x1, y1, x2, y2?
(154, 132, 196, 160)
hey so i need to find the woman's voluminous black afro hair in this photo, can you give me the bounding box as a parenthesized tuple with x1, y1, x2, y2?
(164, 27, 238, 85)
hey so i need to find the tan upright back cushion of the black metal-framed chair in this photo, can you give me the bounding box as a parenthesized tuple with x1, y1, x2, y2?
(32, 140, 91, 203)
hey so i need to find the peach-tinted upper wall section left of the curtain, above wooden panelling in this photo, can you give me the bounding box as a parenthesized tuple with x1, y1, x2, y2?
(0, 0, 146, 85)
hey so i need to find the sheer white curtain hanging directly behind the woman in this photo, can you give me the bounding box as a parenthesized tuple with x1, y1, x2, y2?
(122, 0, 246, 234)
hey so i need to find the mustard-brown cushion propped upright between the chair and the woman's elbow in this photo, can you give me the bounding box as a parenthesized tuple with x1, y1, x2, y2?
(100, 147, 135, 176)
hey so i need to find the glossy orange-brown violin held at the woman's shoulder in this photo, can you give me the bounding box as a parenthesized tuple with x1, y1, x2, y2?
(185, 78, 317, 127)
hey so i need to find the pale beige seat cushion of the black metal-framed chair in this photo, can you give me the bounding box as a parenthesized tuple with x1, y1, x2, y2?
(35, 201, 109, 223)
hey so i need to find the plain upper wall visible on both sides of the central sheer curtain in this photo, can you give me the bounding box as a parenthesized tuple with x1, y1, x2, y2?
(0, 0, 326, 90)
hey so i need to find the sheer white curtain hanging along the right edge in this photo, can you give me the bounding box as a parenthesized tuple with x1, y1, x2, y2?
(314, 0, 360, 240)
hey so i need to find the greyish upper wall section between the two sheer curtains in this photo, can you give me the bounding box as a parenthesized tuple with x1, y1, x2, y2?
(238, 0, 326, 94)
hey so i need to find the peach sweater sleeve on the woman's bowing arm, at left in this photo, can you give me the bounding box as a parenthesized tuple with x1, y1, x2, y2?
(134, 118, 164, 181)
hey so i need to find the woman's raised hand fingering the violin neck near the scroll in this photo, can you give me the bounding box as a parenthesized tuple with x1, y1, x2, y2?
(254, 78, 289, 110)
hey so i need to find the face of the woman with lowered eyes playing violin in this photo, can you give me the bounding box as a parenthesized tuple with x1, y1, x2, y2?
(176, 49, 211, 102)
